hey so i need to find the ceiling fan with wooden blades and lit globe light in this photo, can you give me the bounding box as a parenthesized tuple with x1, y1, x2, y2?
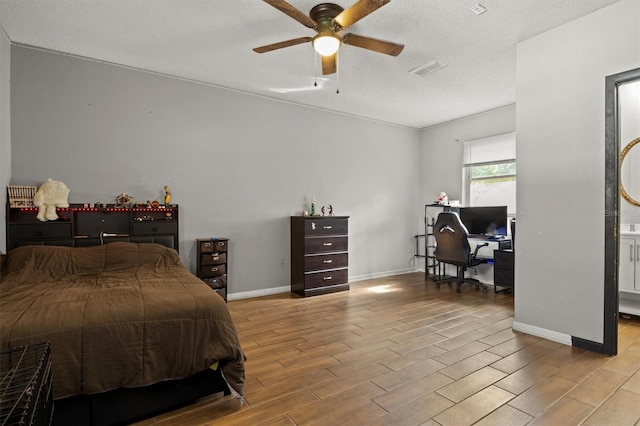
(253, 0, 404, 75)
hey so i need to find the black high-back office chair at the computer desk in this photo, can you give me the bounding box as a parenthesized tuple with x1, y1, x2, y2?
(433, 211, 489, 293)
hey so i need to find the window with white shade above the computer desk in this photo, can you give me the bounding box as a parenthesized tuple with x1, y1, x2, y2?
(462, 133, 516, 216)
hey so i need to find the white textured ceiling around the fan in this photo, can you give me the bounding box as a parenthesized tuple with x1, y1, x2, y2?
(0, 0, 619, 128)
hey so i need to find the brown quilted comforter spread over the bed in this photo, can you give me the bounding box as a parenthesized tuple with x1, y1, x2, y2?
(0, 242, 244, 399)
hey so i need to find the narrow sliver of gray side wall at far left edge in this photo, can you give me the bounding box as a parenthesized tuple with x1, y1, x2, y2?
(0, 31, 11, 253)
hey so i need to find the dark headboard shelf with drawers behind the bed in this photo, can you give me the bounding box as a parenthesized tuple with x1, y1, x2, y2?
(6, 203, 179, 252)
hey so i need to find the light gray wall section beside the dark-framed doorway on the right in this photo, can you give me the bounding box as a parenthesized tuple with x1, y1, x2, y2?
(514, 0, 640, 342)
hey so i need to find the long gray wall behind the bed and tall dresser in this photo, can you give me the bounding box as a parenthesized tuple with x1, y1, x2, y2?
(11, 46, 419, 297)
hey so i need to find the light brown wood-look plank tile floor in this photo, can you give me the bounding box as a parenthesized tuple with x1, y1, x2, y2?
(141, 273, 640, 426)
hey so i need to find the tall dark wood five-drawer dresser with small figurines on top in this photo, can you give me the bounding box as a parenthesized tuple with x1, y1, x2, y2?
(291, 216, 349, 297)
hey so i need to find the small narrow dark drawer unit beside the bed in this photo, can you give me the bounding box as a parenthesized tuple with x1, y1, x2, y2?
(196, 238, 229, 302)
